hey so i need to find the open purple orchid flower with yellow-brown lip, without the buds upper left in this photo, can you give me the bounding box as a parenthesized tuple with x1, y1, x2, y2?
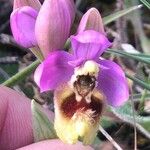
(34, 9, 129, 144)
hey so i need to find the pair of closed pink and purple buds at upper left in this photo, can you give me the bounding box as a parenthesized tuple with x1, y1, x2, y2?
(10, 0, 75, 58)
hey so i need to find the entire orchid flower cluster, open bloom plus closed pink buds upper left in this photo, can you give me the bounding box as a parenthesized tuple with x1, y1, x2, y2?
(11, 0, 129, 144)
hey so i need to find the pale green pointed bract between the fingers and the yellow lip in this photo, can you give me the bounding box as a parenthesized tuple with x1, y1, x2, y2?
(31, 100, 57, 142)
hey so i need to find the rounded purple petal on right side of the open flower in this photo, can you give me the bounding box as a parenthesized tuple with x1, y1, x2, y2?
(98, 60, 129, 106)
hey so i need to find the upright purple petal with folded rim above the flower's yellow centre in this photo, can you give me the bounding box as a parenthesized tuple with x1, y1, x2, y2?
(71, 30, 111, 59)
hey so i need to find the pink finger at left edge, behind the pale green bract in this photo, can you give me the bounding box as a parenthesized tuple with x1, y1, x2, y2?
(0, 86, 54, 150)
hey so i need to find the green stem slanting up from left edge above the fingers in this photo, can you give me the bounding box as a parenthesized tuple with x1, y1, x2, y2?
(2, 60, 40, 87)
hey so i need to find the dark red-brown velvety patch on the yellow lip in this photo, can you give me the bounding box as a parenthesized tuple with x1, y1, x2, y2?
(61, 93, 103, 119)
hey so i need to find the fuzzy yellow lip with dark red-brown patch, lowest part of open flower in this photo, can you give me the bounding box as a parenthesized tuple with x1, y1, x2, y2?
(54, 83, 105, 144)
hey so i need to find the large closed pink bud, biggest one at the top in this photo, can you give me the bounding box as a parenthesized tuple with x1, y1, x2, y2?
(35, 0, 75, 57)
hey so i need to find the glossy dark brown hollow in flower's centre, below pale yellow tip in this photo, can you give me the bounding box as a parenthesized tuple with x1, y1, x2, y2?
(74, 74, 96, 98)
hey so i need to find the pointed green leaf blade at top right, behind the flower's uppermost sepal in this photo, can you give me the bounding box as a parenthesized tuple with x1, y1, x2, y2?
(103, 5, 142, 25)
